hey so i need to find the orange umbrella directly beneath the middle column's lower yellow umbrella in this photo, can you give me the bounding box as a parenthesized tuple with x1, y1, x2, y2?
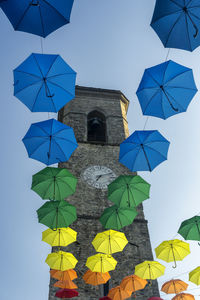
(83, 270, 110, 285)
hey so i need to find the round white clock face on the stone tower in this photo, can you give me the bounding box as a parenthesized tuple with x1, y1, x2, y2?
(82, 166, 117, 190)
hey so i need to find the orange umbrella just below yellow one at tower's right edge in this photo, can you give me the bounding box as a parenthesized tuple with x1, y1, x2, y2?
(120, 275, 148, 292)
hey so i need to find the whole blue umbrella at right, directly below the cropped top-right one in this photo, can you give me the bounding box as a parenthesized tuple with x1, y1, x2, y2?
(136, 60, 197, 119)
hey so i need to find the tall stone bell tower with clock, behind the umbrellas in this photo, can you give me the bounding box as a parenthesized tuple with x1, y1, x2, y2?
(49, 86, 159, 300)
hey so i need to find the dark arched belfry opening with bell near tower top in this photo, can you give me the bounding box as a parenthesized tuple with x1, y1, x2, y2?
(87, 110, 106, 143)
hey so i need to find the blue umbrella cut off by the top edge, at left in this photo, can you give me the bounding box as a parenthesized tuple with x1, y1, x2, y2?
(0, 0, 74, 37)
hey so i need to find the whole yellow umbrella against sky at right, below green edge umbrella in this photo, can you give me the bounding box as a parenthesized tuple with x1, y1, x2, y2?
(155, 239, 190, 268)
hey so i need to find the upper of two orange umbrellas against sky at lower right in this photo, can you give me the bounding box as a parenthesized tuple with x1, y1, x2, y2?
(161, 279, 188, 294)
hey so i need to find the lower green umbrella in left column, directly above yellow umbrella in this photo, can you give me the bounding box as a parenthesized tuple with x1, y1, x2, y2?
(37, 201, 77, 229)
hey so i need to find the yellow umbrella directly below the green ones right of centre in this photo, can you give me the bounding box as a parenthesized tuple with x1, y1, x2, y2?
(92, 230, 128, 254)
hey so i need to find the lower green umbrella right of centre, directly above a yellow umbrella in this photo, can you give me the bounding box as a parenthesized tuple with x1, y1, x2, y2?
(100, 205, 138, 230)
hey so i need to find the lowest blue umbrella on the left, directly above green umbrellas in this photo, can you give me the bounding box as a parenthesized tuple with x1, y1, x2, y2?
(22, 119, 78, 165)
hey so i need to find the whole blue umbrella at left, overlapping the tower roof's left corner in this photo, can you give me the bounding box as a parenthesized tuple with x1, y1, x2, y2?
(14, 53, 76, 112)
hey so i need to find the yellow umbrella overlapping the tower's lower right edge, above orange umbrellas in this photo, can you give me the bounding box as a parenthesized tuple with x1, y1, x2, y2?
(135, 260, 165, 280)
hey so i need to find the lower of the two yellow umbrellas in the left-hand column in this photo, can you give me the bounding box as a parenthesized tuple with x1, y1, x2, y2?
(45, 251, 78, 271)
